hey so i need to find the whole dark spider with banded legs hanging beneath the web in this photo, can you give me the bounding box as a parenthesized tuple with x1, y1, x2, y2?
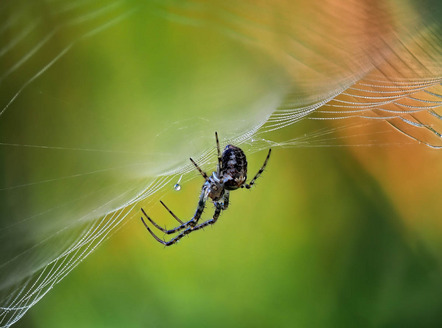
(141, 132, 272, 246)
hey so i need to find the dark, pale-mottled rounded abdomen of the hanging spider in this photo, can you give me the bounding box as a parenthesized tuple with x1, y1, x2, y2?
(221, 145, 247, 190)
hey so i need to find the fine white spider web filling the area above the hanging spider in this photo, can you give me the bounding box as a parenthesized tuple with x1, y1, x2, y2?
(0, 0, 442, 327)
